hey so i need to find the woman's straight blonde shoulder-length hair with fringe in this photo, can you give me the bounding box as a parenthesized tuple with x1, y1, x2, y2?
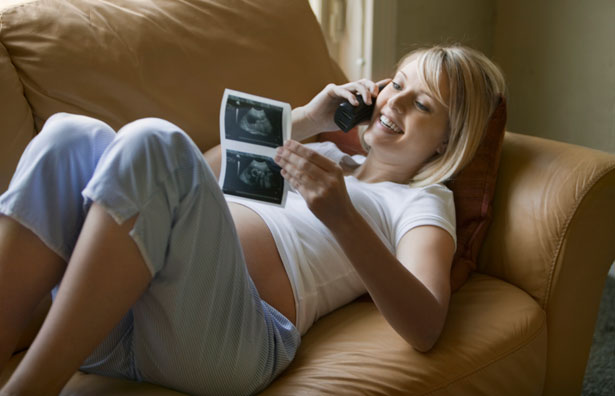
(361, 45, 506, 187)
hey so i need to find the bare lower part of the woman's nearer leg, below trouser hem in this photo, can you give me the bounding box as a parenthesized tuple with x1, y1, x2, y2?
(3, 204, 151, 395)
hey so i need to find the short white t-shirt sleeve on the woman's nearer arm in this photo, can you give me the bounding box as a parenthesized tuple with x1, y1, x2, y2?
(393, 184, 457, 249)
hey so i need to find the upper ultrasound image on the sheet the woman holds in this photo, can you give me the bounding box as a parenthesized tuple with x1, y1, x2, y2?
(224, 95, 283, 147)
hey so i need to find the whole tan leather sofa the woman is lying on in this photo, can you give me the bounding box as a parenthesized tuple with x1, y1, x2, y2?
(0, 0, 615, 395)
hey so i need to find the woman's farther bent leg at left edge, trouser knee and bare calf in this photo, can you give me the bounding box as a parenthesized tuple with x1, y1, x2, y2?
(0, 113, 115, 378)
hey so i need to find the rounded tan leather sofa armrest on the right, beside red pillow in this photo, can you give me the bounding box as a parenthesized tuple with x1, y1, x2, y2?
(479, 132, 615, 394)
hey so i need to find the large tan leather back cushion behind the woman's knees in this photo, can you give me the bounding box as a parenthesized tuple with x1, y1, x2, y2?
(0, 0, 344, 190)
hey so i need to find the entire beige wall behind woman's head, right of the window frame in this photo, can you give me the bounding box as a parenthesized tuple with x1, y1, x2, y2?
(396, 0, 615, 152)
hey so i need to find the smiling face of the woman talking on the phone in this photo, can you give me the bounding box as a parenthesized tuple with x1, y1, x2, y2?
(363, 59, 449, 181)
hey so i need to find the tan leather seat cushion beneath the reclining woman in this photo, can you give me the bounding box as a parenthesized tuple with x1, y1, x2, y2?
(2, 273, 547, 395)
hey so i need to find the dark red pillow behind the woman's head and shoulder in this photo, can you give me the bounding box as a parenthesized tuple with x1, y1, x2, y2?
(318, 99, 506, 291)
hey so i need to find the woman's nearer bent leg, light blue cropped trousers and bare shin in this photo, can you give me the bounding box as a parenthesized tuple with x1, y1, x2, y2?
(7, 119, 300, 394)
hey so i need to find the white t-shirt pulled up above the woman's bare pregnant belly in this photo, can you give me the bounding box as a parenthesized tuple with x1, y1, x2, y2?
(226, 142, 456, 334)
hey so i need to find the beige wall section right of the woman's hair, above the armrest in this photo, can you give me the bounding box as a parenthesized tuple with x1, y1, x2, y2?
(493, 0, 615, 152)
